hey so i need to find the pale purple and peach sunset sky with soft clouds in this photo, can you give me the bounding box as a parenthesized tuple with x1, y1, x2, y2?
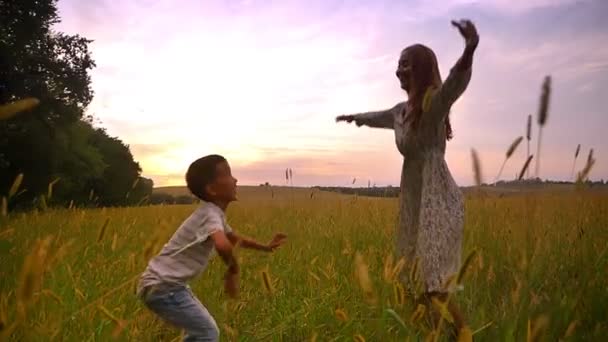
(55, 0, 608, 186)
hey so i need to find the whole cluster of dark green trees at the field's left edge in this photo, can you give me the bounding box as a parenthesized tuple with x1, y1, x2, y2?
(0, 0, 154, 208)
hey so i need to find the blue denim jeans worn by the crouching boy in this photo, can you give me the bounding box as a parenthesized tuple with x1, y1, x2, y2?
(142, 286, 220, 342)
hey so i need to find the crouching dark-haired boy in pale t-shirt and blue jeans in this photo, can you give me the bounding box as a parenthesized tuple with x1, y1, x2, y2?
(138, 155, 286, 341)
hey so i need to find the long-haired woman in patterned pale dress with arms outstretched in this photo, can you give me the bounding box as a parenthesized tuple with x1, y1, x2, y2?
(336, 20, 479, 329)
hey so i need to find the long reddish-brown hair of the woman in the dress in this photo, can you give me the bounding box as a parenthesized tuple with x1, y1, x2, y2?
(403, 44, 452, 140)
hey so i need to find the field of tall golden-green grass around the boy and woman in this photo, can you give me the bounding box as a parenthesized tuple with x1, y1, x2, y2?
(0, 188, 608, 341)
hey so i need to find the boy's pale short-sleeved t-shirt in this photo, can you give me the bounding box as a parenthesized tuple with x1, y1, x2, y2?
(138, 202, 232, 291)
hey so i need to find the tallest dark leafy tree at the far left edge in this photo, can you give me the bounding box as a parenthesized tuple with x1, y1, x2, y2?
(0, 0, 95, 202)
